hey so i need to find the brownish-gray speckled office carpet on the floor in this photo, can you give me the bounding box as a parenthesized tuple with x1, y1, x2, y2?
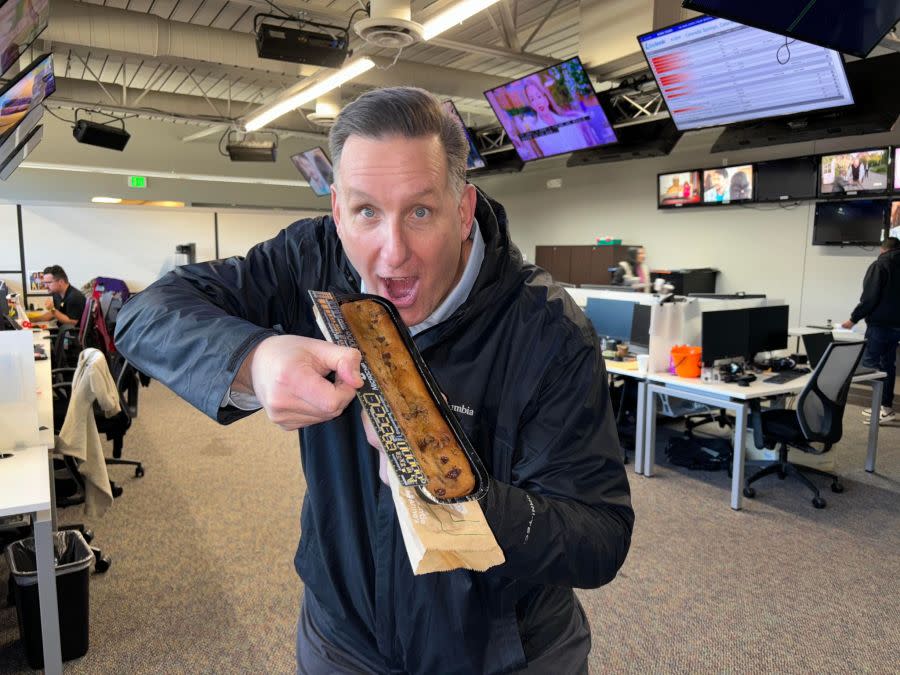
(0, 383, 900, 673)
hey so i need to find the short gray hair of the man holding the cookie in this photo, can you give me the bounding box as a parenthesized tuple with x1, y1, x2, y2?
(328, 87, 469, 194)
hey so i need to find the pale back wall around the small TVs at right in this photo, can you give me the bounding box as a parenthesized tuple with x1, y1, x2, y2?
(477, 131, 900, 324)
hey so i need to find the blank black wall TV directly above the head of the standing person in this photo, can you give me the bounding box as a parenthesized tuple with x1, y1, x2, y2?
(813, 199, 888, 246)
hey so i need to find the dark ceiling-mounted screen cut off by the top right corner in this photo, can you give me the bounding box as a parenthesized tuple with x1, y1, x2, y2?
(683, 0, 900, 58)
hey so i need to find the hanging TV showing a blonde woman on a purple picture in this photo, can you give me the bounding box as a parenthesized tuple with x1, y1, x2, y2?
(484, 57, 616, 162)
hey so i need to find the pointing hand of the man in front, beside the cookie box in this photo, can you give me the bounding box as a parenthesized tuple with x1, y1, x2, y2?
(243, 335, 362, 431)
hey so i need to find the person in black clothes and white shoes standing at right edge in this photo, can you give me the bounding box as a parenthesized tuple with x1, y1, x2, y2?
(841, 237, 900, 424)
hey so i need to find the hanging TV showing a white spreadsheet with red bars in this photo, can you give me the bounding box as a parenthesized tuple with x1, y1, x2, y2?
(638, 16, 853, 131)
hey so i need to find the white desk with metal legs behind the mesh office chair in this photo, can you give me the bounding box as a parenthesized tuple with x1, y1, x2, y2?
(643, 372, 885, 510)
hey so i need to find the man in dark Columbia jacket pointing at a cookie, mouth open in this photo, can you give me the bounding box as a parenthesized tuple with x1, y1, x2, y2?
(116, 87, 634, 674)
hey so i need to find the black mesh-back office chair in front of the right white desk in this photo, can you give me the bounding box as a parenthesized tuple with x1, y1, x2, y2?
(744, 341, 866, 509)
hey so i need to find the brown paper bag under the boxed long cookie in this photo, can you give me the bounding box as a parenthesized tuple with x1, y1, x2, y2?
(387, 468, 506, 574)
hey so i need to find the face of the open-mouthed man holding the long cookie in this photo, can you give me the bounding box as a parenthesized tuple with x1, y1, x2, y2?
(331, 136, 475, 326)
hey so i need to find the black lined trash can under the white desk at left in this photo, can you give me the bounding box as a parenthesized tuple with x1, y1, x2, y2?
(6, 530, 94, 669)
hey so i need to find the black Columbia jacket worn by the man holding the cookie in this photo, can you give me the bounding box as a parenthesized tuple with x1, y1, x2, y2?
(116, 195, 634, 674)
